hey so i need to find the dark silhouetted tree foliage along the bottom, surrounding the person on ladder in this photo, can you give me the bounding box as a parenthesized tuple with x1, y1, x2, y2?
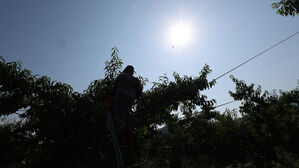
(0, 48, 299, 168)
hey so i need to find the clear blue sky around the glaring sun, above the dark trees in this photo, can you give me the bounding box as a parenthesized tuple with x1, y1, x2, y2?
(0, 0, 299, 111)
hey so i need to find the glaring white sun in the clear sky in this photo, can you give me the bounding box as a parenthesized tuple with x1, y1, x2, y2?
(168, 22, 192, 47)
